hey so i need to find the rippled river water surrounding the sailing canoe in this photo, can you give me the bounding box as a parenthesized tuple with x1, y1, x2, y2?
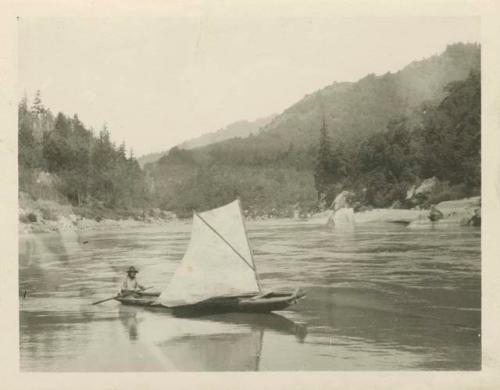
(19, 220, 481, 371)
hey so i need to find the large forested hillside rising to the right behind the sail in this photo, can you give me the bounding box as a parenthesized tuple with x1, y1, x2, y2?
(147, 43, 480, 219)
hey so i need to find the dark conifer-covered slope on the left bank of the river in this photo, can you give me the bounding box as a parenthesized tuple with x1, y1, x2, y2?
(18, 93, 152, 216)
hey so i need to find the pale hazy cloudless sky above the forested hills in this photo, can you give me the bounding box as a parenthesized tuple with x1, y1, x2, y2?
(19, 17, 480, 155)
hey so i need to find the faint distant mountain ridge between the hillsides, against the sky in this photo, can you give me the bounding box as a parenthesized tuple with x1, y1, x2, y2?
(137, 114, 276, 167)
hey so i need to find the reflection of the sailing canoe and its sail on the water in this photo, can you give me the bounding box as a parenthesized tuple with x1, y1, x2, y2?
(119, 306, 307, 371)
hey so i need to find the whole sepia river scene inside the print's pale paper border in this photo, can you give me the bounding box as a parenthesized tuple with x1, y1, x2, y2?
(6, 0, 483, 373)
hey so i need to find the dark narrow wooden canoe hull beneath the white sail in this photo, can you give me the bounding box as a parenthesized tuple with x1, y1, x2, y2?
(116, 291, 305, 317)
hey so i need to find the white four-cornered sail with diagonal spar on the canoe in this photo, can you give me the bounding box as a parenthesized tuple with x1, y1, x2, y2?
(158, 200, 260, 307)
